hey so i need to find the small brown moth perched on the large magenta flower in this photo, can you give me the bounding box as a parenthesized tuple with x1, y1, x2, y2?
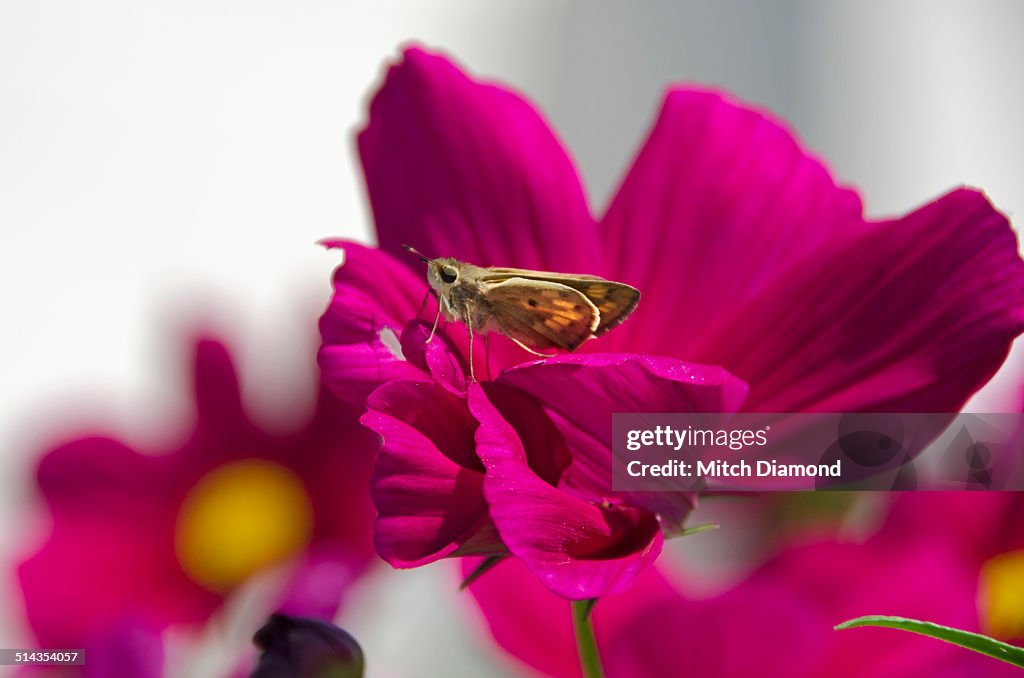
(402, 245, 640, 381)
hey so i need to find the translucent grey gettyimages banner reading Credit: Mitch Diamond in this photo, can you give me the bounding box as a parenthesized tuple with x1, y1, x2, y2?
(612, 414, 1024, 492)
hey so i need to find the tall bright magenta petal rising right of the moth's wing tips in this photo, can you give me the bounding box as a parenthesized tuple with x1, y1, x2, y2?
(603, 89, 860, 356)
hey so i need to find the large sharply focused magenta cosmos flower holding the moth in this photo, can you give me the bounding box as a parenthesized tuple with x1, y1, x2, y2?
(319, 48, 1024, 598)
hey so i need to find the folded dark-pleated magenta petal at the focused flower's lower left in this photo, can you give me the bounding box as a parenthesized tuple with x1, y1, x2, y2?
(361, 381, 504, 567)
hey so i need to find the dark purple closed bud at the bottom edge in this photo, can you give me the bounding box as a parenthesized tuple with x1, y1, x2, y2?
(250, 613, 365, 678)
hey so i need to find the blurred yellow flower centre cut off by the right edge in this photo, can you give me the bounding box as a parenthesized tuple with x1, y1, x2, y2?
(979, 550, 1024, 639)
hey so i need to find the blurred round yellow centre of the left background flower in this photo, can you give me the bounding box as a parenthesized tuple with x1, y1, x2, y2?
(174, 459, 313, 592)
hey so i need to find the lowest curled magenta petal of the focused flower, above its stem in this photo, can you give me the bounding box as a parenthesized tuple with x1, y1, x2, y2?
(469, 384, 663, 599)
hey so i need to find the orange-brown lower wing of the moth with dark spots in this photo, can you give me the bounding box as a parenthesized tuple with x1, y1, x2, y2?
(484, 278, 601, 351)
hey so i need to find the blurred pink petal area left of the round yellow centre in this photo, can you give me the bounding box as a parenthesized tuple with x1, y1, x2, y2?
(18, 438, 219, 647)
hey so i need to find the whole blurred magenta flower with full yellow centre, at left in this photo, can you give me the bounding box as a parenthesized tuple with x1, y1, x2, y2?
(17, 340, 376, 659)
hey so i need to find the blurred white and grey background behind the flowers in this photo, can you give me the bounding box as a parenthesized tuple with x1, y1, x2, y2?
(0, 0, 1024, 676)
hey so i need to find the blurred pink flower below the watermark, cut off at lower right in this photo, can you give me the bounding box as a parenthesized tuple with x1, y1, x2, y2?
(465, 493, 1021, 678)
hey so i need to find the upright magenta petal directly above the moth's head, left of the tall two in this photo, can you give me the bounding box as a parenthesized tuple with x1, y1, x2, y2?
(359, 48, 598, 272)
